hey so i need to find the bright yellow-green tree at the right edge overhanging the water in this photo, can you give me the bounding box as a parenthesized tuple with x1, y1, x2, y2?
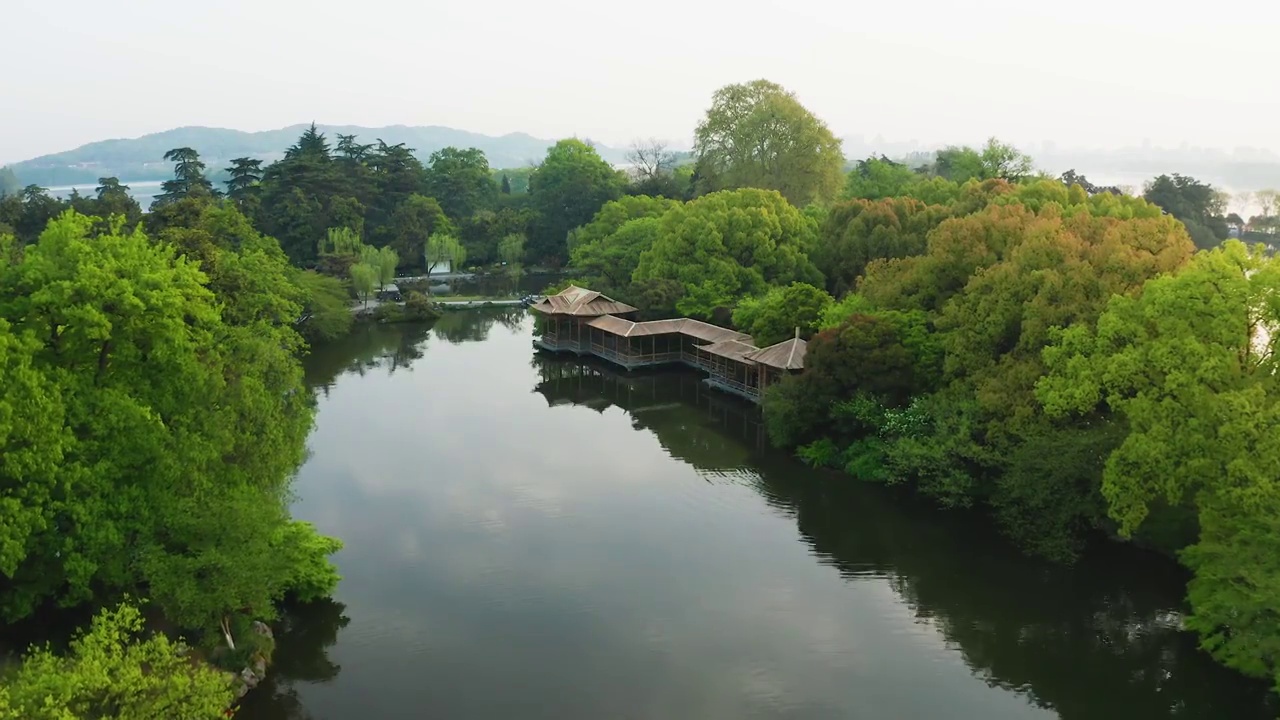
(1037, 241, 1280, 682)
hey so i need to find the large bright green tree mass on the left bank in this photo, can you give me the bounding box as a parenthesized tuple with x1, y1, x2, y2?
(0, 206, 343, 629)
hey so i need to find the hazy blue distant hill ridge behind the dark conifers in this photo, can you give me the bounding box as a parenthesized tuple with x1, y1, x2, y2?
(9, 124, 626, 187)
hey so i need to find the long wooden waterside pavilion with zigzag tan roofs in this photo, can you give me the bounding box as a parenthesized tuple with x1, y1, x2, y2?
(532, 286, 806, 402)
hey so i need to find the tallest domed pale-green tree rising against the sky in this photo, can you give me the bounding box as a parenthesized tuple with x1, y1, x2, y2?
(694, 79, 845, 205)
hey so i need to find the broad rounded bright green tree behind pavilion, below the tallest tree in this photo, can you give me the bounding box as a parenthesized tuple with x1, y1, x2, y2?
(632, 188, 822, 318)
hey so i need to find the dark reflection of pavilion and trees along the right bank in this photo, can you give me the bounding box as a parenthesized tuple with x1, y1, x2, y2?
(534, 356, 1280, 720)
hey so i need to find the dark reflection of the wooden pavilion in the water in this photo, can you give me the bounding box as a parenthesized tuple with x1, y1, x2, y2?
(534, 355, 768, 474)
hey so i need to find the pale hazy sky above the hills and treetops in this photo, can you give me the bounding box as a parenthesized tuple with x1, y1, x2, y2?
(0, 0, 1280, 161)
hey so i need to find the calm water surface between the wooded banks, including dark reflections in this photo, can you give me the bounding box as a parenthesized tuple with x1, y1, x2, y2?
(241, 313, 1276, 720)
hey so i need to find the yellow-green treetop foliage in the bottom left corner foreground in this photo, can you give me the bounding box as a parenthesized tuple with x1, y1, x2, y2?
(0, 605, 236, 720)
